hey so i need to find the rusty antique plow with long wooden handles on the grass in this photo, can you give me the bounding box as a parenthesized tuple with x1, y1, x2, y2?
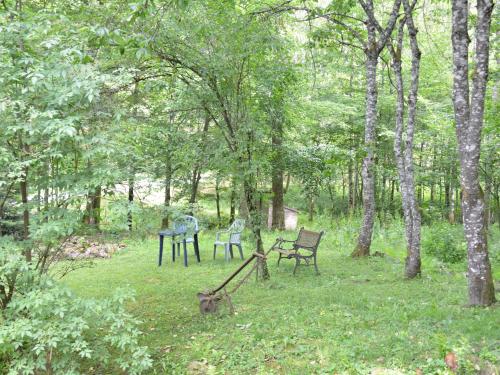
(198, 245, 274, 314)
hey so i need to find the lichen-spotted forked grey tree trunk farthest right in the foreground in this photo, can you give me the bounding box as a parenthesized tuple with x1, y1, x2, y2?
(452, 0, 495, 306)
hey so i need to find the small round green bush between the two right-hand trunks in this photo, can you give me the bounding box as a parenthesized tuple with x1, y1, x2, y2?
(422, 223, 467, 263)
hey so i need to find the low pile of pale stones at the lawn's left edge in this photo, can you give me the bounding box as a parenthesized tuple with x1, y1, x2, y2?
(63, 236, 125, 260)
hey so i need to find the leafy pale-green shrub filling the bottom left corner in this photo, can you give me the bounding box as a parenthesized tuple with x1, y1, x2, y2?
(0, 242, 152, 375)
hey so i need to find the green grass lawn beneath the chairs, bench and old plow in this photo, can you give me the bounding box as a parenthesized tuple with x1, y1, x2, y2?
(63, 216, 500, 374)
